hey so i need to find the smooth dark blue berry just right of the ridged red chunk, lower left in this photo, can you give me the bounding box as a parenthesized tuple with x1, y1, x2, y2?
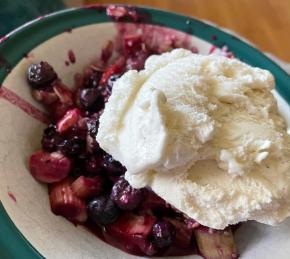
(88, 196, 120, 225)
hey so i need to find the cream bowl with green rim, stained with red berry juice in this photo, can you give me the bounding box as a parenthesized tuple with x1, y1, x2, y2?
(0, 6, 290, 259)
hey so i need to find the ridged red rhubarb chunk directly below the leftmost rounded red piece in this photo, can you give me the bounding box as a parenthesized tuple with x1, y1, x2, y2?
(49, 179, 87, 222)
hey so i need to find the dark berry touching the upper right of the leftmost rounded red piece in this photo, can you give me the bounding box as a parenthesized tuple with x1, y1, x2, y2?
(58, 137, 85, 156)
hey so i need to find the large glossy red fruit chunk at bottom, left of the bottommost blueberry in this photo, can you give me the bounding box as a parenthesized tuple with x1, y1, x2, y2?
(106, 214, 156, 255)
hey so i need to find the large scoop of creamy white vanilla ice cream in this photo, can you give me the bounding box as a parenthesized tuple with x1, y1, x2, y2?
(97, 49, 290, 229)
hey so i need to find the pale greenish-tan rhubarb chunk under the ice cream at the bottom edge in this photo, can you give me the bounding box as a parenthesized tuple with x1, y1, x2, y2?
(194, 227, 238, 259)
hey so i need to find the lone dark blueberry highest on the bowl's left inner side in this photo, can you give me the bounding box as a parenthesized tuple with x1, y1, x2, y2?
(27, 61, 57, 89)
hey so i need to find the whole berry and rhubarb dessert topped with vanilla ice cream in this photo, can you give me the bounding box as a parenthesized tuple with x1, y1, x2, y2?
(27, 21, 289, 259)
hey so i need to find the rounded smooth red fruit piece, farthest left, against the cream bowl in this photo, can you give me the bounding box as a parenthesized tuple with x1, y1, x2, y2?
(29, 150, 72, 183)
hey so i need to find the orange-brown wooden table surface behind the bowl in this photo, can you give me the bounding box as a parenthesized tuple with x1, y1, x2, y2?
(84, 0, 290, 62)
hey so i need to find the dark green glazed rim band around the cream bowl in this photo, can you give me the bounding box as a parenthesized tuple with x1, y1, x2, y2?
(0, 5, 290, 259)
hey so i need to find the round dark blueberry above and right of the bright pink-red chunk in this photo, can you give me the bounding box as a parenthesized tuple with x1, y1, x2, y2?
(80, 88, 104, 111)
